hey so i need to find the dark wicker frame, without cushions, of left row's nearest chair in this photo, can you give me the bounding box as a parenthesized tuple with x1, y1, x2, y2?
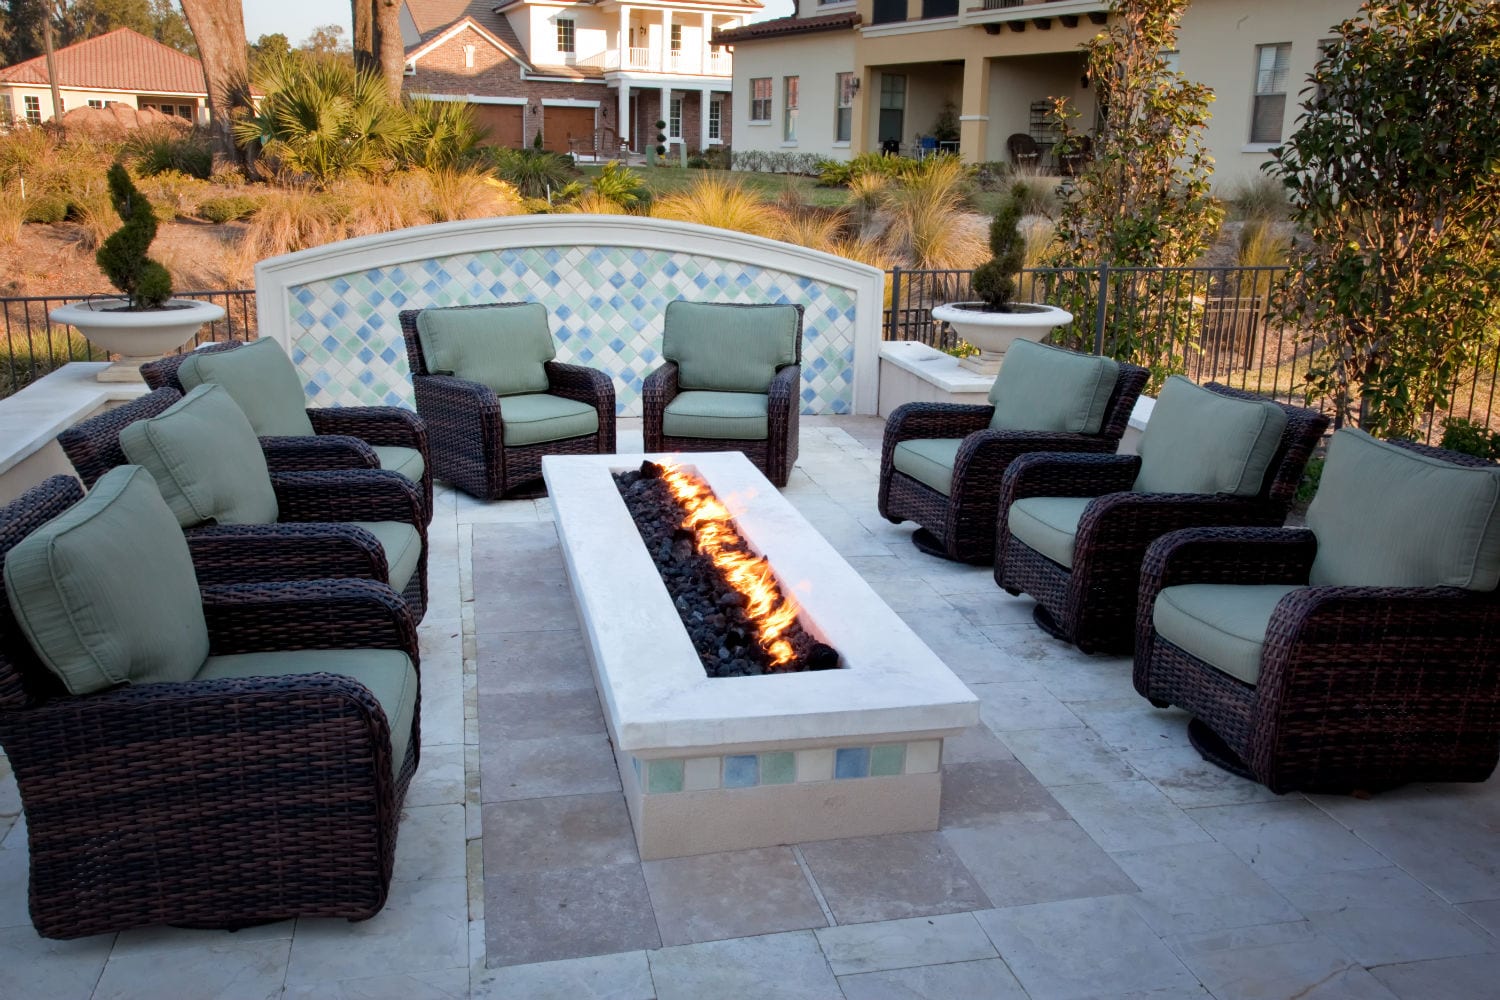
(0, 475, 422, 937)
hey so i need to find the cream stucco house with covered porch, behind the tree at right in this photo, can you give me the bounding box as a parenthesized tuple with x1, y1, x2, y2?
(716, 0, 1359, 184)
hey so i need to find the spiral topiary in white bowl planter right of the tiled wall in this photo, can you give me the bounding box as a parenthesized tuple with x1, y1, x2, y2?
(933, 184, 1073, 375)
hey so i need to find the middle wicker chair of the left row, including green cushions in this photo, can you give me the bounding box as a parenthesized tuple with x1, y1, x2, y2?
(57, 385, 428, 621)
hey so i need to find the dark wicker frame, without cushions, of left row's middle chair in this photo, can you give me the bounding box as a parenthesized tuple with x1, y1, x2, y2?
(57, 388, 428, 621)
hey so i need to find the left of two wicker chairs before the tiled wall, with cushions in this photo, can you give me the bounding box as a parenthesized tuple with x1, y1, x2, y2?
(401, 303, 615, 501)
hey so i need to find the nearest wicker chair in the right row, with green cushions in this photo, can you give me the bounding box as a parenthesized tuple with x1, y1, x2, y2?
(1134, 430, 1500, 792)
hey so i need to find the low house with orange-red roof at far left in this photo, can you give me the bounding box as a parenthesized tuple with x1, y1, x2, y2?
(0, 28, 209, 124)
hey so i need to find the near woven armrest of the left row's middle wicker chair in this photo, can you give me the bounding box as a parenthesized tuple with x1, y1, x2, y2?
(188, 522, 390, 586)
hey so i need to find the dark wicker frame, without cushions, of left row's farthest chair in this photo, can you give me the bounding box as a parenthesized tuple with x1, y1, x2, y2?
(141, 340, 432, 520)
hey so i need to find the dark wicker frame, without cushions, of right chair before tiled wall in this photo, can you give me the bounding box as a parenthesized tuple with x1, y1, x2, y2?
(641, 301, 803, 487)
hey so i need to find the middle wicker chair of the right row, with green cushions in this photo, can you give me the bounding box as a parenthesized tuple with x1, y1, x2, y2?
(995, 375, 1328, 652)
